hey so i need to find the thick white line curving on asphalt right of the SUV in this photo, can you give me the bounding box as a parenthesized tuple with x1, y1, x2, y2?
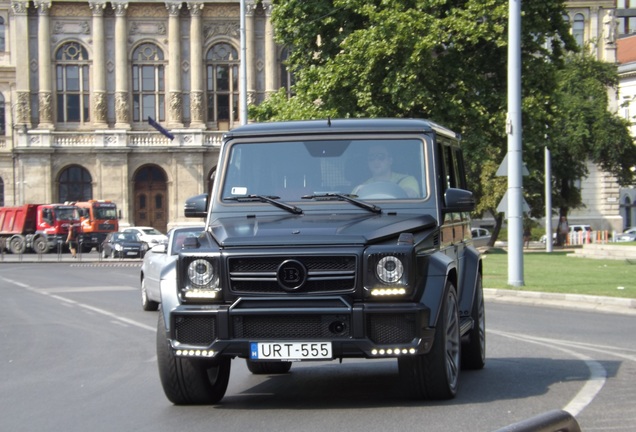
(488, 330, 607, 417)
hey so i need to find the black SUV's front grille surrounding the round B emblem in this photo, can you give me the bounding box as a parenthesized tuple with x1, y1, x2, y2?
(228, 255, 356, 294)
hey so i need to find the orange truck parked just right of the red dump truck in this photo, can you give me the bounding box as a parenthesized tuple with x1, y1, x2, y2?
(72, 200, 119, 252)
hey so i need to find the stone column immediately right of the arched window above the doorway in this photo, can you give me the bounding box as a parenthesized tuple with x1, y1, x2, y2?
(166, 3, 183, 128)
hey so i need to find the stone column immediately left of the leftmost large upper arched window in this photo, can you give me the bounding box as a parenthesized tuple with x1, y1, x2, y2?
(33, 1, 54, 130)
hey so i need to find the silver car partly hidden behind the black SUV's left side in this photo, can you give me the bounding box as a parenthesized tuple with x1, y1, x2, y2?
(140, 226, 205, 311)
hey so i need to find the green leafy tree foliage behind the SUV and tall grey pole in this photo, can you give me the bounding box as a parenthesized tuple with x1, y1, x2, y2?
(250, 0, 634, 226)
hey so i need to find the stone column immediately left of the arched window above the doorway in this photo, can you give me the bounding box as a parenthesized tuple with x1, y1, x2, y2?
(111, 2, 130, 129)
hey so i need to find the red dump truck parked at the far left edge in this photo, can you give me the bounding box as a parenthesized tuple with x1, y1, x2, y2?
(0, 204, 79, 254)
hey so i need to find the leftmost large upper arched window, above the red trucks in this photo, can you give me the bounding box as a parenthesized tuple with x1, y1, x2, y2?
(55, 42, 90, 123)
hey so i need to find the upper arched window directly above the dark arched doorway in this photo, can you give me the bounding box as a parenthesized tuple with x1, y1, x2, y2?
(132, 43, 166, 122)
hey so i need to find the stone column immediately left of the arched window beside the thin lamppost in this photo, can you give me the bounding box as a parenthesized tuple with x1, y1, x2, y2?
(188, 3, 206, 128)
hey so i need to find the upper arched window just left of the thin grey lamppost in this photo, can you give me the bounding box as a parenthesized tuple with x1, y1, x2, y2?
(205, 43, 239, 122)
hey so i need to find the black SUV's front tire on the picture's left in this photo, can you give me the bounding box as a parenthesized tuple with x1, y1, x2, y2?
(157, 313, 231, 405)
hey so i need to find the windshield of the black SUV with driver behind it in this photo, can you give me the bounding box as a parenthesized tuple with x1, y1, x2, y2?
(222, 138, 428, 201)
